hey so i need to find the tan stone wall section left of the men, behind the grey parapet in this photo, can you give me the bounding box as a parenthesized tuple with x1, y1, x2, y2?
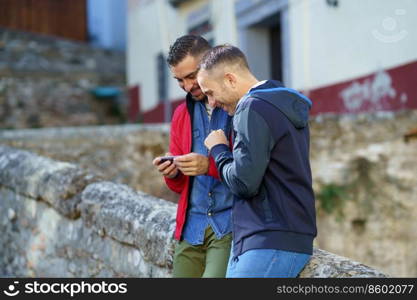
(0, 124, 174, 202)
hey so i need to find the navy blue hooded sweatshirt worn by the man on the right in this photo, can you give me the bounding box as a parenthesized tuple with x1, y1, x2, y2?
(211, 80, 317, 257)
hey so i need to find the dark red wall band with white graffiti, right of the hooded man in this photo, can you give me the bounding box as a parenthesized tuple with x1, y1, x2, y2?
(305, 61, 417, 115)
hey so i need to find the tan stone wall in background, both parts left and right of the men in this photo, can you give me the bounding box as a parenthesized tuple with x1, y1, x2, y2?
(0, 111, 417, 277)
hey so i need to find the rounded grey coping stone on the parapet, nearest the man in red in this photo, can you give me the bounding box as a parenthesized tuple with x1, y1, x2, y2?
(81, 182, 176, 267)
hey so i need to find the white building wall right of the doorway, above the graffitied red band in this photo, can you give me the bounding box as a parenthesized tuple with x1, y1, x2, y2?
(289, 0, 417, 89)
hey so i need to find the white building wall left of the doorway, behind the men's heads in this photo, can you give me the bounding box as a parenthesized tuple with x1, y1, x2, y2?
(127, 0, 237, 111)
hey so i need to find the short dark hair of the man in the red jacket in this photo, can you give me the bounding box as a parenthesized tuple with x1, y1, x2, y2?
(167, 35, 211, 66)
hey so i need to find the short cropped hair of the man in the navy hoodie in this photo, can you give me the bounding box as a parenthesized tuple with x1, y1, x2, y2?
(200, 44, 249, 70)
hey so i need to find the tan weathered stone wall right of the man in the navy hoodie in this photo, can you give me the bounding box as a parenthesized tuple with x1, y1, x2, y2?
(310, 111, 417, 277)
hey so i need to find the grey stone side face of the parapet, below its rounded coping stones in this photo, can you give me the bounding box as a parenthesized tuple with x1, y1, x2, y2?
(0, 189, 171, 277)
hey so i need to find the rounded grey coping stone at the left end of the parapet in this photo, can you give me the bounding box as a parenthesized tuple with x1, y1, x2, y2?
(0, 146, 99, 218)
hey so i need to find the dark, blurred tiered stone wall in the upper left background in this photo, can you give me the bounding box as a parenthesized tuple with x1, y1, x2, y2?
(0, 28, 127, 129)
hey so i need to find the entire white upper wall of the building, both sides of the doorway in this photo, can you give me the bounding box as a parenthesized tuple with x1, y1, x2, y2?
(127, 0, 417, 111)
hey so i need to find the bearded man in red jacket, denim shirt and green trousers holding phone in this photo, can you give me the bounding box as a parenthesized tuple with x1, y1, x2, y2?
(153, 35, 233, 277)
